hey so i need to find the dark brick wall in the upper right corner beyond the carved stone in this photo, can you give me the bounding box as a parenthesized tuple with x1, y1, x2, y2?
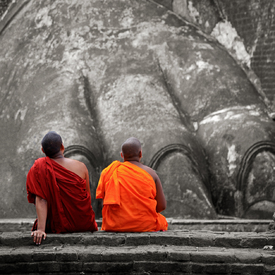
(218, 0, 275, 111)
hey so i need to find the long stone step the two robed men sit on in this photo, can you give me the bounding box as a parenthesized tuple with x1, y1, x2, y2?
(0, 230, 275, 249)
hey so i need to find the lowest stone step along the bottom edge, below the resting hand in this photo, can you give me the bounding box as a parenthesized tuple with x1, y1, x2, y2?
(0, 245, 275, 275)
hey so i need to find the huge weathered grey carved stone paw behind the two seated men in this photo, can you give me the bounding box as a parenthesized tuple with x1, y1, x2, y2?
(0, 0, 275, 219)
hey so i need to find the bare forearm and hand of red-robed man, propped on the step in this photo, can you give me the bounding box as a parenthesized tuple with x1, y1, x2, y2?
(31, 196, 48, 244)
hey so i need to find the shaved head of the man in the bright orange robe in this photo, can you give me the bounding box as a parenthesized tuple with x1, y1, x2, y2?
(121, 137, 141, 160)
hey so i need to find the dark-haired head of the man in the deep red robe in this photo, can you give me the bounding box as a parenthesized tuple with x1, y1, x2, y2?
(41, 131, 62, 158)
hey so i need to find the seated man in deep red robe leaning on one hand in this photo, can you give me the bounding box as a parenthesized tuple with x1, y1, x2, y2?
(27, 131, 98, 244)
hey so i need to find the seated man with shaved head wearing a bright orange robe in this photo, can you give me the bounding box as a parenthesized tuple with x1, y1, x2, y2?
(96, 137, 168, 232)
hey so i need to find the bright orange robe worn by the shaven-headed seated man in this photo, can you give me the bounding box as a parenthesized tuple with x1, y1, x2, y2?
(97, 162, 167, 232)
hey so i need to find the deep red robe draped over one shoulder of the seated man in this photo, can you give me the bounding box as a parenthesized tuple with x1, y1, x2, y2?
(26, 157, 98, 233)
